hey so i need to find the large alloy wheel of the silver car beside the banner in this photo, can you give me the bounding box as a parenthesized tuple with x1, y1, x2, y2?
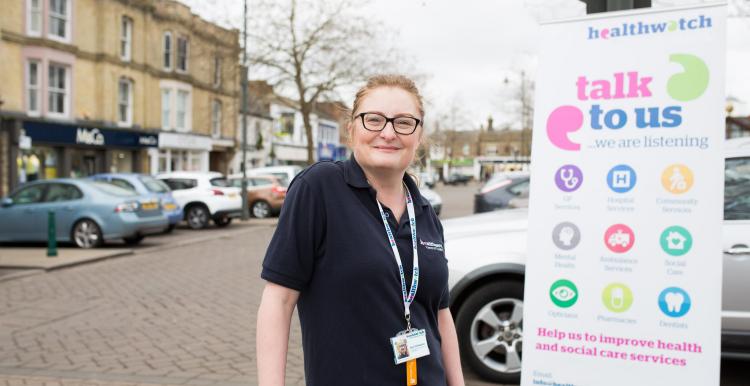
(456, 281, 523, 384)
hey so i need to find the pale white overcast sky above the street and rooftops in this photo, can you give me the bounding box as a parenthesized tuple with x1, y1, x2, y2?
(181, 0, 750, 129)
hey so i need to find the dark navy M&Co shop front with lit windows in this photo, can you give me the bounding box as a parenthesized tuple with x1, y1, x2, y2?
(13, 121, 159, 186)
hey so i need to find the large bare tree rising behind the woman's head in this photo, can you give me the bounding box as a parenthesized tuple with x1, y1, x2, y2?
(248, 0, 396, 163)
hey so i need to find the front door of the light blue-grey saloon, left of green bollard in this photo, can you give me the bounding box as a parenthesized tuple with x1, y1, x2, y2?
(0, 184, 47, 241)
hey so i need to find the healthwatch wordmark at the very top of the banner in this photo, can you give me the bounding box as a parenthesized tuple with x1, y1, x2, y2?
(588, 15, 711, 40)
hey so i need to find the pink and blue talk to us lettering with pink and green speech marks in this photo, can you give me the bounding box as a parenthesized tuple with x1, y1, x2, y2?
(546, 53, 710, 151)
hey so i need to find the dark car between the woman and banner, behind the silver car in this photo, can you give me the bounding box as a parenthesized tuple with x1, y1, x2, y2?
(474, 173, 529, 213)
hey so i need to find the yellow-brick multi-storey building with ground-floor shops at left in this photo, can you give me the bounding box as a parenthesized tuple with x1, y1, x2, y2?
(0, 0, 239, 194)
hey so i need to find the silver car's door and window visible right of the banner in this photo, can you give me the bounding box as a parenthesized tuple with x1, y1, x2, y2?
(722, 156, 750, 331)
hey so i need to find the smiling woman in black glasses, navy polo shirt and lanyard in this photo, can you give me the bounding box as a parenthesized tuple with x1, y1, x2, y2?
(256, 75, 464, 386)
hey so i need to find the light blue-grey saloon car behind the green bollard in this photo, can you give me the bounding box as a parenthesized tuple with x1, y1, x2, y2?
(0, 178, 169, 248)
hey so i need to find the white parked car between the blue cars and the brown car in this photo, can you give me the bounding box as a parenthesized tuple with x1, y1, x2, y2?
(156, 172, 242, 229)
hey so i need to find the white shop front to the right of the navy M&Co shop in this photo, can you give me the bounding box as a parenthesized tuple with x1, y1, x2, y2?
(149, 133, 213, 174)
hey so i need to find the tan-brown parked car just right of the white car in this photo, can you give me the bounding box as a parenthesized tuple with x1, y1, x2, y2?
(229, 174, 287, 218)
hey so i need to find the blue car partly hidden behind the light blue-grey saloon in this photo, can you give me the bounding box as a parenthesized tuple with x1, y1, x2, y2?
(89, 173, 183, 232)
